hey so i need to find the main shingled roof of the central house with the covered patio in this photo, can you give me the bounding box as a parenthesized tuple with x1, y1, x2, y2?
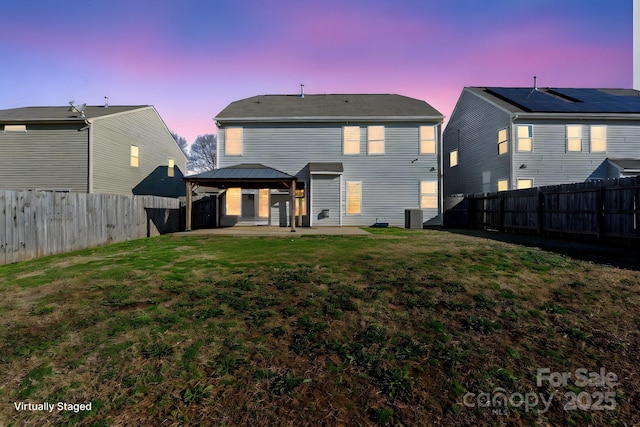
(216, 94, 443, 123)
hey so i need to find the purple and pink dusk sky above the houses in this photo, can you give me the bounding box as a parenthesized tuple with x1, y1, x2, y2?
(0, 0, 633, 143)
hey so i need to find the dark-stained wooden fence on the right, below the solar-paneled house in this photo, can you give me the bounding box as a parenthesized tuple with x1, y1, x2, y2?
(444, 177, 640, 243)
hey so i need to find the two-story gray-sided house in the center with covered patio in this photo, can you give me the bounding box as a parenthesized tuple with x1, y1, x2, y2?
(185, 94, 443, 226)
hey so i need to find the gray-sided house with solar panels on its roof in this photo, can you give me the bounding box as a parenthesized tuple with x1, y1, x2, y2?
(443, 87, 640, 196)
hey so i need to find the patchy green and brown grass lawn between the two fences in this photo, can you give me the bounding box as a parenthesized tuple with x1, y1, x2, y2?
(0, 229, 640, 426)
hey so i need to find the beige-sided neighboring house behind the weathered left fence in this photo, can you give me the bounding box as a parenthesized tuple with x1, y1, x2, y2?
(0, 106, 186, 196)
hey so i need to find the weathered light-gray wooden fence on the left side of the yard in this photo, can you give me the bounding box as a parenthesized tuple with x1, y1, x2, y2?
(0, 190, 181, 265)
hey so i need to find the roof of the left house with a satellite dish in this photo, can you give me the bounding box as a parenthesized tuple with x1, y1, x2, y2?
(0, 105, 149, 123)
